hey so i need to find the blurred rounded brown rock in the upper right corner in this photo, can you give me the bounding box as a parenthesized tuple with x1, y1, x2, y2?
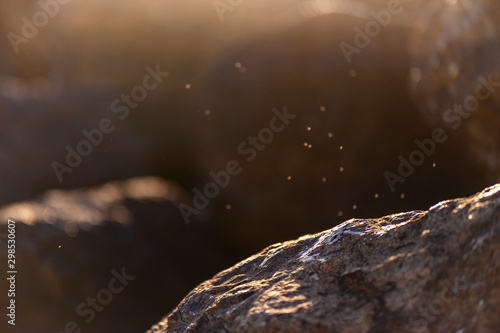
(409, 0, 500, 181)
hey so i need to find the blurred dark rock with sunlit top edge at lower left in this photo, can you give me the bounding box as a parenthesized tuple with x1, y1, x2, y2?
(0, 177, 228, 333)
